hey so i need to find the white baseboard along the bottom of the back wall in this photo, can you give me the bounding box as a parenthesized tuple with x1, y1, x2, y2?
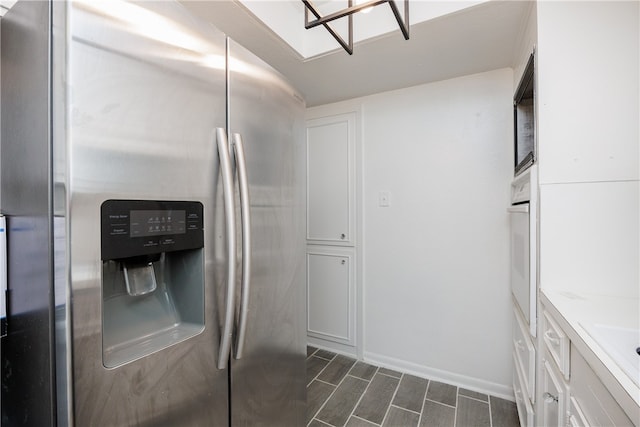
(364, 352, 515, 402)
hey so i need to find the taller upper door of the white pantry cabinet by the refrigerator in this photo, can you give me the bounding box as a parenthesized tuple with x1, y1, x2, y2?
(307, 113, 355, 246)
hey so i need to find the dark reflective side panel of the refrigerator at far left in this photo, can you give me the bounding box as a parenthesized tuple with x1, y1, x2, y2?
(0, 2, 56, 427)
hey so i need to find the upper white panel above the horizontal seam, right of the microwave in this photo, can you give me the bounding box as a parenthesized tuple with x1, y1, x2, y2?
(537, 1, 640, 183)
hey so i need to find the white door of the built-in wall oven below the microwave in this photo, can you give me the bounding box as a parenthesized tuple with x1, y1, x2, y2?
(507, 203, 536, 336)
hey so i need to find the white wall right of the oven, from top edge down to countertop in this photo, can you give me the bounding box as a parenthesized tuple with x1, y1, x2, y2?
(537, 1, 640, 298)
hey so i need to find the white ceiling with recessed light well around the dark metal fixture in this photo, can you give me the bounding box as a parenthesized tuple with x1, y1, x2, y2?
(0, 0, 532, 106)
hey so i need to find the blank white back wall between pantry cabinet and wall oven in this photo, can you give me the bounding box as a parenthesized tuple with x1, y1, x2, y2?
(310, 69, 513, 397)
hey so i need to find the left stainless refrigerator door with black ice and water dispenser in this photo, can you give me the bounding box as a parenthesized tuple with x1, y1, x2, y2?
(67, 1, 229, 426)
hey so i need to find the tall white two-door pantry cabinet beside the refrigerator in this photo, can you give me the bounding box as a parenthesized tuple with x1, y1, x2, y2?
(306, 112, 357, 356)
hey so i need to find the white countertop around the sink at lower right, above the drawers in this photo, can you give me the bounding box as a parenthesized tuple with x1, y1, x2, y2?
(540, 289, 640, 426)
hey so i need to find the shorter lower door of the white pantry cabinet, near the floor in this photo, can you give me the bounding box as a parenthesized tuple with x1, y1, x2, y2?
(307, 248, 355, 345)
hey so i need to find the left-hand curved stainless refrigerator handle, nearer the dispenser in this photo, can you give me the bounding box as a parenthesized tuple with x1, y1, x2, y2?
(216, 128, 236, 369)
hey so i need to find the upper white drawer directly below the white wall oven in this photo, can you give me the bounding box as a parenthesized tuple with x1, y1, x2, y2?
(513, 306, 536, 403)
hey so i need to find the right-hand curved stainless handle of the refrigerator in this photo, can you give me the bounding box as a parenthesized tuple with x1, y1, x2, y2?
(233, 133, 251, 359)
